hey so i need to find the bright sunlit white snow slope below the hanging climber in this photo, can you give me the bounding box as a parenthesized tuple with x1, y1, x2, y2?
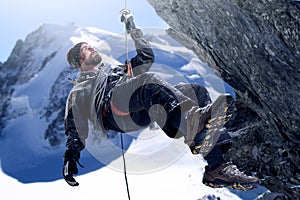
(0, 129, 266, 200)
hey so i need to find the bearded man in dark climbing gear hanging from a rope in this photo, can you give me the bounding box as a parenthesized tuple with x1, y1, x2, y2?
(63, 10, 258, 190)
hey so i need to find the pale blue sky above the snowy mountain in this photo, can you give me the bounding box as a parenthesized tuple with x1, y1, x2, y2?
(0, 0, 168, 62)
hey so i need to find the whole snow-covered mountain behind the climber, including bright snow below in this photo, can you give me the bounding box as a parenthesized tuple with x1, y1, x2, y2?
(0, 24, 265, 200)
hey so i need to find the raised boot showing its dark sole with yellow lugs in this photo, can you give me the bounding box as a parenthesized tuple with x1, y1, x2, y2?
(186, 94, 235, 156)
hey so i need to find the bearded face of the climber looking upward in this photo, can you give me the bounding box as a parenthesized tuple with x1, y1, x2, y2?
(80, 43, 102, 66)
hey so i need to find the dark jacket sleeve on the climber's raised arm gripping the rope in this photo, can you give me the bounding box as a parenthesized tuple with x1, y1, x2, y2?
(130, 29, 154, 76)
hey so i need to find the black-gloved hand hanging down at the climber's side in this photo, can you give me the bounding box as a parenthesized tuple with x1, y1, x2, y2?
(62, 149, 80, 186)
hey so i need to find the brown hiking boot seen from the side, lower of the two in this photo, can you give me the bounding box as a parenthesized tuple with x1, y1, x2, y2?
(202, 162, 258, 191)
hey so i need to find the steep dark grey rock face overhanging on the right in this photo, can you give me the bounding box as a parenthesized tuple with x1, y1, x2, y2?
(148, 0, 300, 199)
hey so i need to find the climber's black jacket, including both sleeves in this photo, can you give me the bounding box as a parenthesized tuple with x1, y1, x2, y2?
(65, 29, 154, 151)
